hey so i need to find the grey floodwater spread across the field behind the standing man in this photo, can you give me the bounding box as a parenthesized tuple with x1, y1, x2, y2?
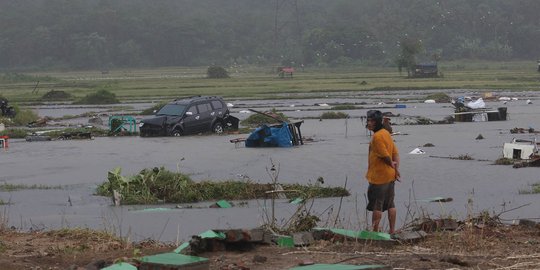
(0, 90, 540, 242)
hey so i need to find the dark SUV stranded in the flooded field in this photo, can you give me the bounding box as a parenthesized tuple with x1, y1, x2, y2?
(139, 96, 238, 136)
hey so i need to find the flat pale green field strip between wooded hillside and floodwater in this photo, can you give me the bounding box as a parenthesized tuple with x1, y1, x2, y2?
(0, 61, 540, 104)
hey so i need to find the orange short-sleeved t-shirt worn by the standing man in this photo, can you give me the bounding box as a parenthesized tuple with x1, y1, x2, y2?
(366, 128, 398, 185)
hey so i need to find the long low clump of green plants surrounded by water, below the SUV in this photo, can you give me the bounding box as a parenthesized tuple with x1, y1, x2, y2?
(96, 167, 349, 204)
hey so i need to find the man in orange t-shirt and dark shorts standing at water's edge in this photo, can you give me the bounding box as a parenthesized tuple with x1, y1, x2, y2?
(366, 110, 400, 234)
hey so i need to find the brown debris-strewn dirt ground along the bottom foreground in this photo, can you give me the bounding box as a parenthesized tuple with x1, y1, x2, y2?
(0, 225, 540, 270)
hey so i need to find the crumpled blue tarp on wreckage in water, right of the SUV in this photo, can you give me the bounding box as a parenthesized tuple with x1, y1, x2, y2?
(246, 123, 293, 147)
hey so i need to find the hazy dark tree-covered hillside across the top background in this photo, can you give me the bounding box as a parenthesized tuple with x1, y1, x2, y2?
(0, 0, 540, 70)
